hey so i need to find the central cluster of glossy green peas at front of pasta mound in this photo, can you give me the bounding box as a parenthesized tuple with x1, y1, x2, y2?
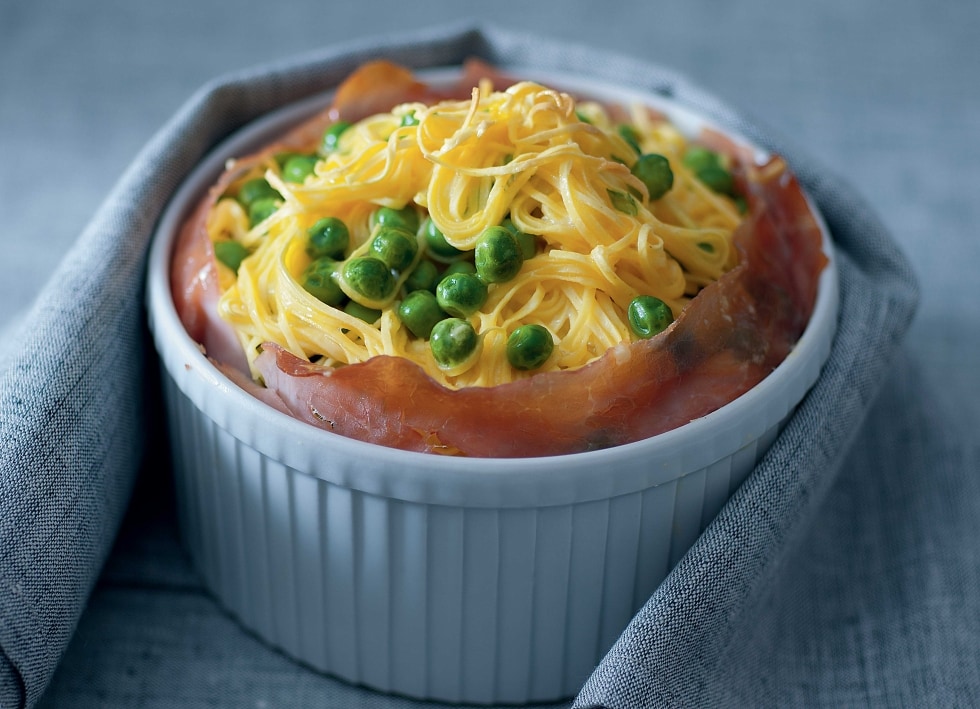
(302, 201, 554, 370)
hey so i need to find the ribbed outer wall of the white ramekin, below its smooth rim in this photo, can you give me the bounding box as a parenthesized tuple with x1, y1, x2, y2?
(166, 370, 777, 703)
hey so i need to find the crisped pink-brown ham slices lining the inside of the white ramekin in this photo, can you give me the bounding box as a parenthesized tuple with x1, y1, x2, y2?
(173, 60, 826, 457)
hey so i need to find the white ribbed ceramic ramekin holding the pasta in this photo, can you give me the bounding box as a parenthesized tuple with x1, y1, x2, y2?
(148, 65, 837, 704)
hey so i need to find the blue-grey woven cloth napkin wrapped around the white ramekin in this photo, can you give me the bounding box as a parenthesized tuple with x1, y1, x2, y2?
(0, 26, 916, 707)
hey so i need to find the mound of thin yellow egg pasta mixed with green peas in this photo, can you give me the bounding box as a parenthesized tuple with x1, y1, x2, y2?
(207, 81, 743, 388)
